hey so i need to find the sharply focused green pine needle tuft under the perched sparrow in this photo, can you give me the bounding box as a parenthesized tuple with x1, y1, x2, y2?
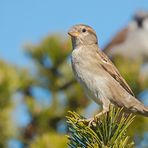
(67, 106, 134, 148)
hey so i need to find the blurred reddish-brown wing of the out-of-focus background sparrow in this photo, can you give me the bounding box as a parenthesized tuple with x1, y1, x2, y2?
(103, 28, 128, 53)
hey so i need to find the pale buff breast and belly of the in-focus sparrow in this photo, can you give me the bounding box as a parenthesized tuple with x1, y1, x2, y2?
(71, 48, 108, 103)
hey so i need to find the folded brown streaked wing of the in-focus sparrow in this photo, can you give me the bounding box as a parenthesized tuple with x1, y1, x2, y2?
(97, 50, 134, 96)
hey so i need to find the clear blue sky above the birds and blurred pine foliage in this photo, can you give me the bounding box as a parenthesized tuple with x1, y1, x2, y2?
(0, 0, 148, 66)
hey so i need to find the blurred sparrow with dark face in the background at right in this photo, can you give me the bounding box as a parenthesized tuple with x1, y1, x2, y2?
(103, 10, 148, 62)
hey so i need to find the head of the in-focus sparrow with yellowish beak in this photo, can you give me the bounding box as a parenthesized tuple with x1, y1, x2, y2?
(68, 24, 98, 48)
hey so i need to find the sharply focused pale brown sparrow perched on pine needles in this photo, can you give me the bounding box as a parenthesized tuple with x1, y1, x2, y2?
(68, 24, 148, 117)
